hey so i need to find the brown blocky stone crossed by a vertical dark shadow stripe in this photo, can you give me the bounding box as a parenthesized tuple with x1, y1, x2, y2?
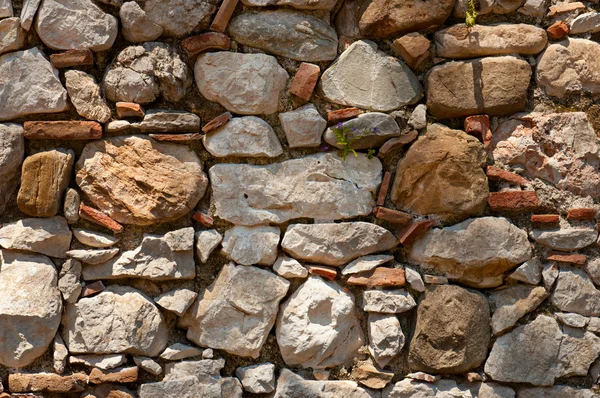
(427, 55, 531, 119)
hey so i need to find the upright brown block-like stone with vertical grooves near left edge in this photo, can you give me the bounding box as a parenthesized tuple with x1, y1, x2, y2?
(17, 148, 75, 217)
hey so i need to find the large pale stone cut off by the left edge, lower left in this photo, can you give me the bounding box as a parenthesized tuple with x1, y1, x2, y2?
(0, 250, 62, 366)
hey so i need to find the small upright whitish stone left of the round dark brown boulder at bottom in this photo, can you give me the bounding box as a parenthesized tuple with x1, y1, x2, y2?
(367, 313, 405, 368)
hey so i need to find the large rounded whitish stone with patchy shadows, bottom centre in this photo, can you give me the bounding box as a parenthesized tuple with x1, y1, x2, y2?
(276, 276, 364, 369)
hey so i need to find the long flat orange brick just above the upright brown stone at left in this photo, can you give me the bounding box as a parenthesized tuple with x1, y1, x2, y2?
(23, 120, 102, 140)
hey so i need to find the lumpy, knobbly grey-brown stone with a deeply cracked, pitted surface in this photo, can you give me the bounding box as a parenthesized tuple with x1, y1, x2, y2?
(103, 42, 192, 104)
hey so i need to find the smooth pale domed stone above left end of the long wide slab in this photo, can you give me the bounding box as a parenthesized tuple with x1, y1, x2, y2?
(202, 116, 283, 158)
